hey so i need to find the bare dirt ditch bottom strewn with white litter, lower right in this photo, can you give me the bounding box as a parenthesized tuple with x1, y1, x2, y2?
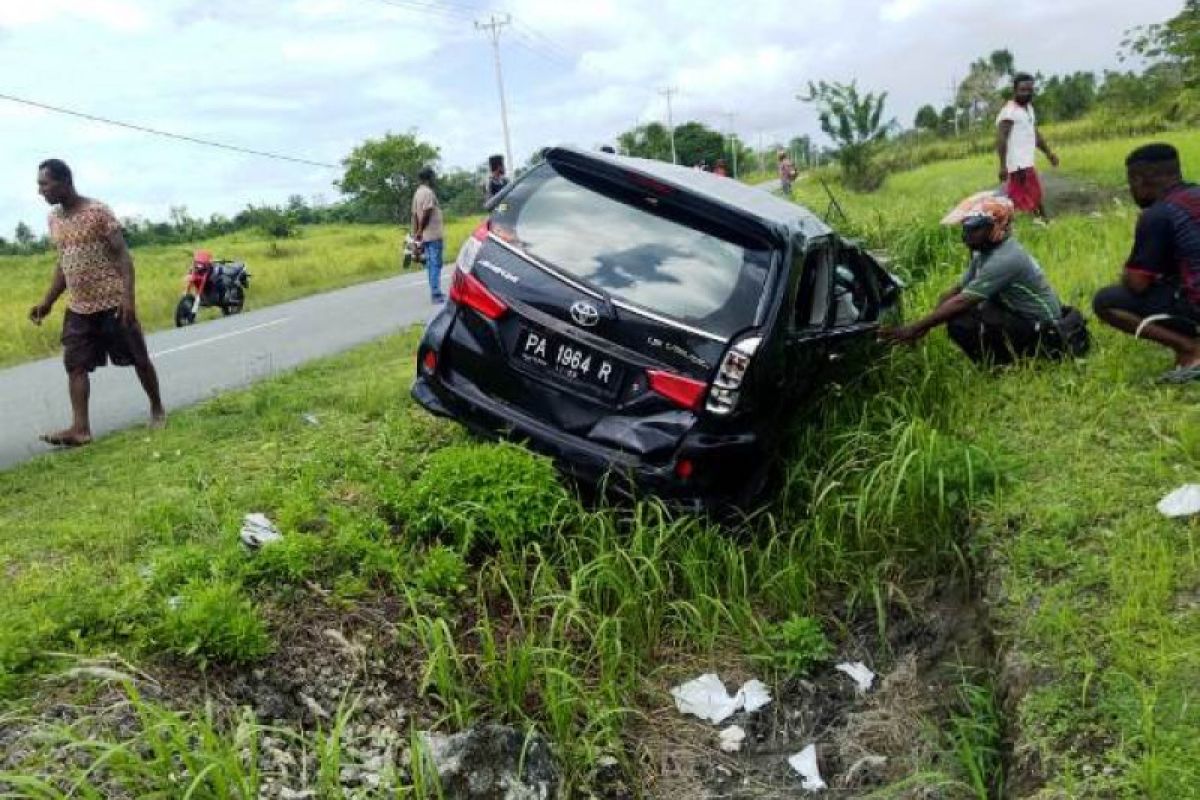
(643, 589, 1003, 800)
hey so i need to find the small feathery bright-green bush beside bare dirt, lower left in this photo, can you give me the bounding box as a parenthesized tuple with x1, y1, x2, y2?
(154, 582, 274, 667)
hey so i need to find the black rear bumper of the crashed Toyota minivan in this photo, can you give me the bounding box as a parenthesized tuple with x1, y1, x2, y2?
(410, 374, 766, 503)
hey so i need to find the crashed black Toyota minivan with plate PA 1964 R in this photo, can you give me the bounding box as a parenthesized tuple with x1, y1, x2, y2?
(413, 148, 900, 505)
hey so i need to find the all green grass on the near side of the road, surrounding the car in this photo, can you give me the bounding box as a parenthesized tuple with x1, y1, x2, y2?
(0, 134, 1200, 799)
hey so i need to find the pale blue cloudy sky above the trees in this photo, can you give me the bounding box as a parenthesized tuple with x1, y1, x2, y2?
(0, 0, 1182, 239)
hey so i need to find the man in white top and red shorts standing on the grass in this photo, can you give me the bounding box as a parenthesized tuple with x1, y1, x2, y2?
(996, 72, 1058, 219)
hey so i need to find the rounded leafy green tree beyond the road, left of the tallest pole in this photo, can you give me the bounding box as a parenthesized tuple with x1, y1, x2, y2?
(334, 133, 439, 222)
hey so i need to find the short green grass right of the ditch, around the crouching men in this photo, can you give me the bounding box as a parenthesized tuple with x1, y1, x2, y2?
(798, 133, 1200, 798)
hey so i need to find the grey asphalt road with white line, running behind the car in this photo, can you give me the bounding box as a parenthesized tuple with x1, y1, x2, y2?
(0, 271, 454, 469)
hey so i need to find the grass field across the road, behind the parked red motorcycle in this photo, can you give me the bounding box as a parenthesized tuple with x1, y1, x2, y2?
(0, 219, 475, 367)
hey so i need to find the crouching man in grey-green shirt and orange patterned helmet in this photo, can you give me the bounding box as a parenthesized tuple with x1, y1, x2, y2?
(880, 193, 1087, 363)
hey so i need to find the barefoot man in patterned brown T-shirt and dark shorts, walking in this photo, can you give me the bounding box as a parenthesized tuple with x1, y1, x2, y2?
(29, 158, 167, 447)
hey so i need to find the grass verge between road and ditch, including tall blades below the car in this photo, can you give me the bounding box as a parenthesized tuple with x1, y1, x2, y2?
(0, 321, 996, 793)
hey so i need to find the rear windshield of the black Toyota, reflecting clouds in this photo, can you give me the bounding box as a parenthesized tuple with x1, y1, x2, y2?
(493, 164, 770, 338)
